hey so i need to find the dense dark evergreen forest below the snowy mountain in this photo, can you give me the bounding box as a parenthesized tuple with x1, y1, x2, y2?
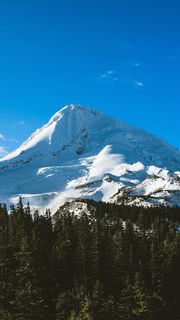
(0, 199, 180, 320)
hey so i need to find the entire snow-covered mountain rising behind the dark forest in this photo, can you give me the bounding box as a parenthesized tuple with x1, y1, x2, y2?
(0, 105, 180, 209)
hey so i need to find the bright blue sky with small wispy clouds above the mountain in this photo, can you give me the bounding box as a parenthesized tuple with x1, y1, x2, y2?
(0, 0, 180, 155)
